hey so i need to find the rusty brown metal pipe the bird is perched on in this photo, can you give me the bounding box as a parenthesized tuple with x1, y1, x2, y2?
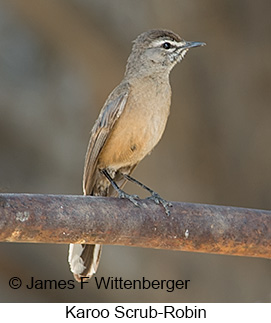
(0, 194, 271, 258)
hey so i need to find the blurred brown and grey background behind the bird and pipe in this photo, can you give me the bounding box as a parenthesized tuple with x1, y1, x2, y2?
(0, 0, 271, 302)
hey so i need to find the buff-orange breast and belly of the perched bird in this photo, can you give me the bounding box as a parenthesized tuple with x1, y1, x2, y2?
(99, 78, 171, 169)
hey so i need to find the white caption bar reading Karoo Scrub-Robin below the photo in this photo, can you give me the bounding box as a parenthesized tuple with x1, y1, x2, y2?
(0, 303, 271, 323)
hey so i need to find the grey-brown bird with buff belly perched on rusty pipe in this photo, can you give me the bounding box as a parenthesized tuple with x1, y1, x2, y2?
(68, 29, 205, 282)
